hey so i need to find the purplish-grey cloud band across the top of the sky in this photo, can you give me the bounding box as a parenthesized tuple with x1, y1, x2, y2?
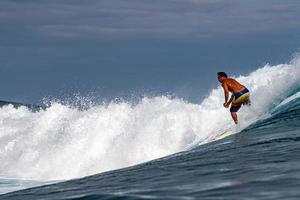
(0, 0, 300, 38)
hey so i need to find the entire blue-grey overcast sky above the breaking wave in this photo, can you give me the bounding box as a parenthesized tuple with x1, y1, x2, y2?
(0, 0, 300, 102)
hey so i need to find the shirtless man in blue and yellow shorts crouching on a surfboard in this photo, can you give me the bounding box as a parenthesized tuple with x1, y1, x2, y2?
(218, 72, 250, 124)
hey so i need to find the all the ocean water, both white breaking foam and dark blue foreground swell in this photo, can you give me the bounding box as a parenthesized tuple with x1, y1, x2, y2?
(0, 59, 300, 199)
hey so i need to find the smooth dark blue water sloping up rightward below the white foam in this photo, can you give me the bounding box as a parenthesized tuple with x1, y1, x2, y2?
(0, 96, 300, 200)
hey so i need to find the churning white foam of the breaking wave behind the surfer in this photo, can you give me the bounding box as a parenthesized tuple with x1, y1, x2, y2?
(0, 58, 300, 195)
